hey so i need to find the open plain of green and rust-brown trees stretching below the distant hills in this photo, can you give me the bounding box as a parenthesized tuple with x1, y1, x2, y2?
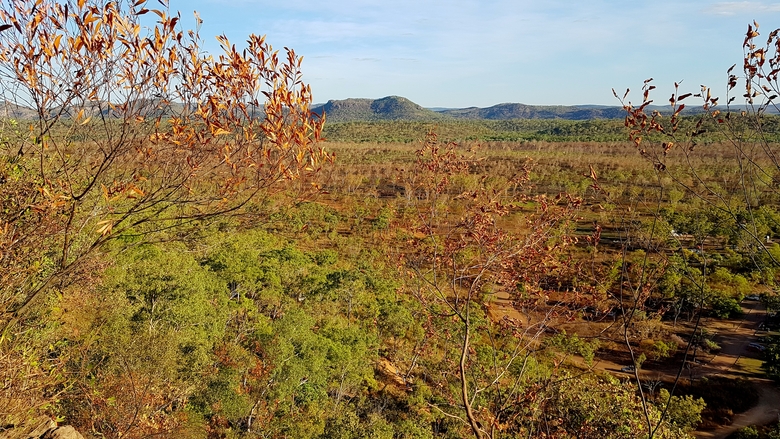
(3, 114, 780, 438)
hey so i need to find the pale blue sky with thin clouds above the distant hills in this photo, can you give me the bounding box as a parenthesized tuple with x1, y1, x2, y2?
(169, 0, 780, 108)
